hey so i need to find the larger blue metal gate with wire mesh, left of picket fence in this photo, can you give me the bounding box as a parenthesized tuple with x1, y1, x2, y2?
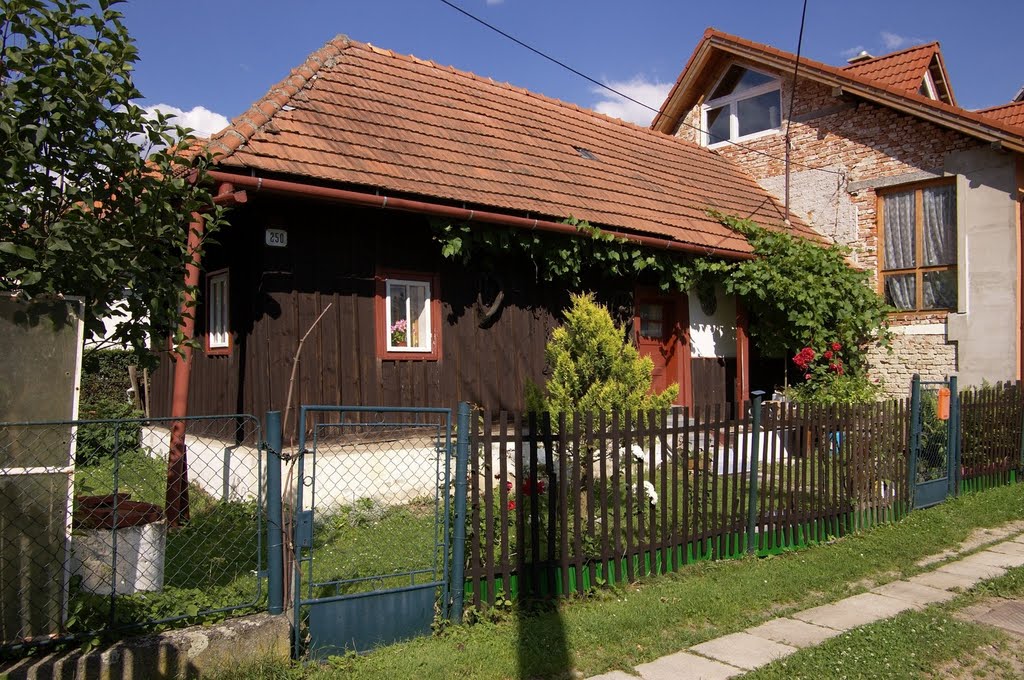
(294, 406, 454, 658)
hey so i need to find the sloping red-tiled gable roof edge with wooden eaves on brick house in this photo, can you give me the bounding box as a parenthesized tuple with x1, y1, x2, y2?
(651, 29, 1024, 152)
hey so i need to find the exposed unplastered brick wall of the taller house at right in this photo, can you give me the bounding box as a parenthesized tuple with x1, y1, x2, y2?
(676, 66, 984, 394)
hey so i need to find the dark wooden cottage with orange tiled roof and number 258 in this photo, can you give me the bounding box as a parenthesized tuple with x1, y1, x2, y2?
(154, 37, 812, 415)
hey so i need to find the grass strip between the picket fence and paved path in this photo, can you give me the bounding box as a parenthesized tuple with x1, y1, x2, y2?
(203, 485, 1024, 679)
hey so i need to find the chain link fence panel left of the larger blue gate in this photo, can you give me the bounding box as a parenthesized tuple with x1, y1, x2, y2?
(0, 416, 266, 651)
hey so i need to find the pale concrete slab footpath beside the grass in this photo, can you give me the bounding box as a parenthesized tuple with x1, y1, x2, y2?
(590, 521, 1024, 680)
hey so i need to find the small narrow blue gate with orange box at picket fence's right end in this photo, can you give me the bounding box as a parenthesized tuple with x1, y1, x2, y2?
(908, 375, 961, 509)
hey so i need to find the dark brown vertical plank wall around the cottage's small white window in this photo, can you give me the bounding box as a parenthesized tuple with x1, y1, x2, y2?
(154, 193, 568, 416)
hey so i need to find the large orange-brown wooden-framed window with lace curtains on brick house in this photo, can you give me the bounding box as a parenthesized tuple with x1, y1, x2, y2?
(879, 182, 956, 311)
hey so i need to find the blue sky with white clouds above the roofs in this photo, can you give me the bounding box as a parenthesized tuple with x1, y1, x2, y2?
(122, 0, 1024, 132)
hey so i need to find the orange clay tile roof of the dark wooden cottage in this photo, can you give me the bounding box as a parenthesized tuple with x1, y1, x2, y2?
(211, 36, 815, 258)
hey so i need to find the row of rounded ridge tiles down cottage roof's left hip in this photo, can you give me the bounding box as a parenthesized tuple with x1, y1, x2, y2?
(208, 34, 358, 162)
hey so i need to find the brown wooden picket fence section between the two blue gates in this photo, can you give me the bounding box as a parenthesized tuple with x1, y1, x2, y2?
(466, 400, 909, 606)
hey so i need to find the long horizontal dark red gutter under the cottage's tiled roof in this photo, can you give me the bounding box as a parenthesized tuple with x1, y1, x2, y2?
(206, 170, 754, 260)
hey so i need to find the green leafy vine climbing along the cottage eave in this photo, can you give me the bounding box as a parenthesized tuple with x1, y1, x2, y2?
(434, 212, 890, 375)
